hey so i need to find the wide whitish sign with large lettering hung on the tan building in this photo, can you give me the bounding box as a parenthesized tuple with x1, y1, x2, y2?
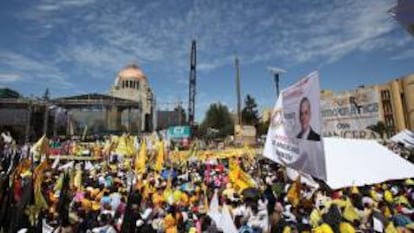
(321, 87, 380, 139)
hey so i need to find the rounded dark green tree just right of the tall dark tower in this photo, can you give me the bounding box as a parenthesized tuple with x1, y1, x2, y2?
(199, 103, 234, 138)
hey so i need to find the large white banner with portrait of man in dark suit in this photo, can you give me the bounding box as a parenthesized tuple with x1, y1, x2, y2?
(264, 72, 326, 180)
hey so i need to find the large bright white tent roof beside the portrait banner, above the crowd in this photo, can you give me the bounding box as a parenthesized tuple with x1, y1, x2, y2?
(324, 138, 414, 189)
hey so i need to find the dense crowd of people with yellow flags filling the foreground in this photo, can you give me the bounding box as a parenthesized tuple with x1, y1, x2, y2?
(0, 133, 414, 233)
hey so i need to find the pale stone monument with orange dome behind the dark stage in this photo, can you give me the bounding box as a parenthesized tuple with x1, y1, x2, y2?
(110, 65, 155, 131)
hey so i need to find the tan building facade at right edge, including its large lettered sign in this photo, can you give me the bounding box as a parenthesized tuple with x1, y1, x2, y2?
(321, 74, 414, 138)
